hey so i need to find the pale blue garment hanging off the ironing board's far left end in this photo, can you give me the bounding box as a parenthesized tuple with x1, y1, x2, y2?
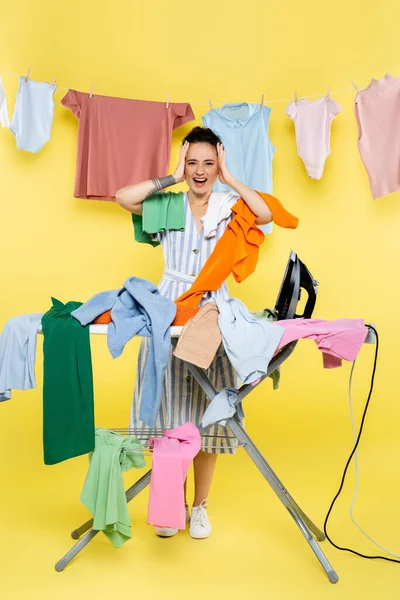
(0, 313, 43, 402)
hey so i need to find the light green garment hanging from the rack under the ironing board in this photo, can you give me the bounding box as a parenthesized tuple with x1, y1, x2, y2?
(81, 428, 146, 548)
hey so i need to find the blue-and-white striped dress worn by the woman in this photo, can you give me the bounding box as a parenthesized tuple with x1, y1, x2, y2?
(130, 192, 238, 454)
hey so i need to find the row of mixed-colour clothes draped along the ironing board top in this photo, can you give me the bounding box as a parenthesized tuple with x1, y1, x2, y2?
(0, 277, 367, 464)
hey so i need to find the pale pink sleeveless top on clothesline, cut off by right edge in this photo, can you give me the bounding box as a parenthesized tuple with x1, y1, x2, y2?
(354, 73, 400, 200)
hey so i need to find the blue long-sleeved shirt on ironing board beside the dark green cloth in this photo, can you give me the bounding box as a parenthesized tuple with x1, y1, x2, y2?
(72, 277, 176, 427)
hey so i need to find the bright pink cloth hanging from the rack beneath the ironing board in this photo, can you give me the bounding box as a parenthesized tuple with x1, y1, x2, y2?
(148, 423, 201, 529)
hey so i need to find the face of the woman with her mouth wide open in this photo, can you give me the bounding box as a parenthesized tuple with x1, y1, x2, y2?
(185, 143, 218, 195)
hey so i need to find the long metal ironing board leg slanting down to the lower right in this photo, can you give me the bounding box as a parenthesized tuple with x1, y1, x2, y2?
(227, 418, 339, 583)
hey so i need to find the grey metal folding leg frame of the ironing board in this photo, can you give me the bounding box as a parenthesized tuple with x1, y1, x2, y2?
(55, 325, 339, 583)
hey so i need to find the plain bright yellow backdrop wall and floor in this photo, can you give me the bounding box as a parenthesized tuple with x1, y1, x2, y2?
(0, 0, 400, 600)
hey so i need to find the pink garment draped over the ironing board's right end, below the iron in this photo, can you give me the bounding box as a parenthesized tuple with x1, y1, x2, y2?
(275, 319, 368, 369)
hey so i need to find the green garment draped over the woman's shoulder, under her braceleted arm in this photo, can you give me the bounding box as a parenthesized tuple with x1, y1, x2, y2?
(132, 192, 185, 246)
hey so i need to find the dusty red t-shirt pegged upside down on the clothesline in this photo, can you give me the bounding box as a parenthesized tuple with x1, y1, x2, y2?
(61, 90, 194, 200)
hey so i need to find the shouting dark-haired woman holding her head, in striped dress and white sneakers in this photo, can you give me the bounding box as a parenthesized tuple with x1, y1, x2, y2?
(116, 127, 272, 538)
